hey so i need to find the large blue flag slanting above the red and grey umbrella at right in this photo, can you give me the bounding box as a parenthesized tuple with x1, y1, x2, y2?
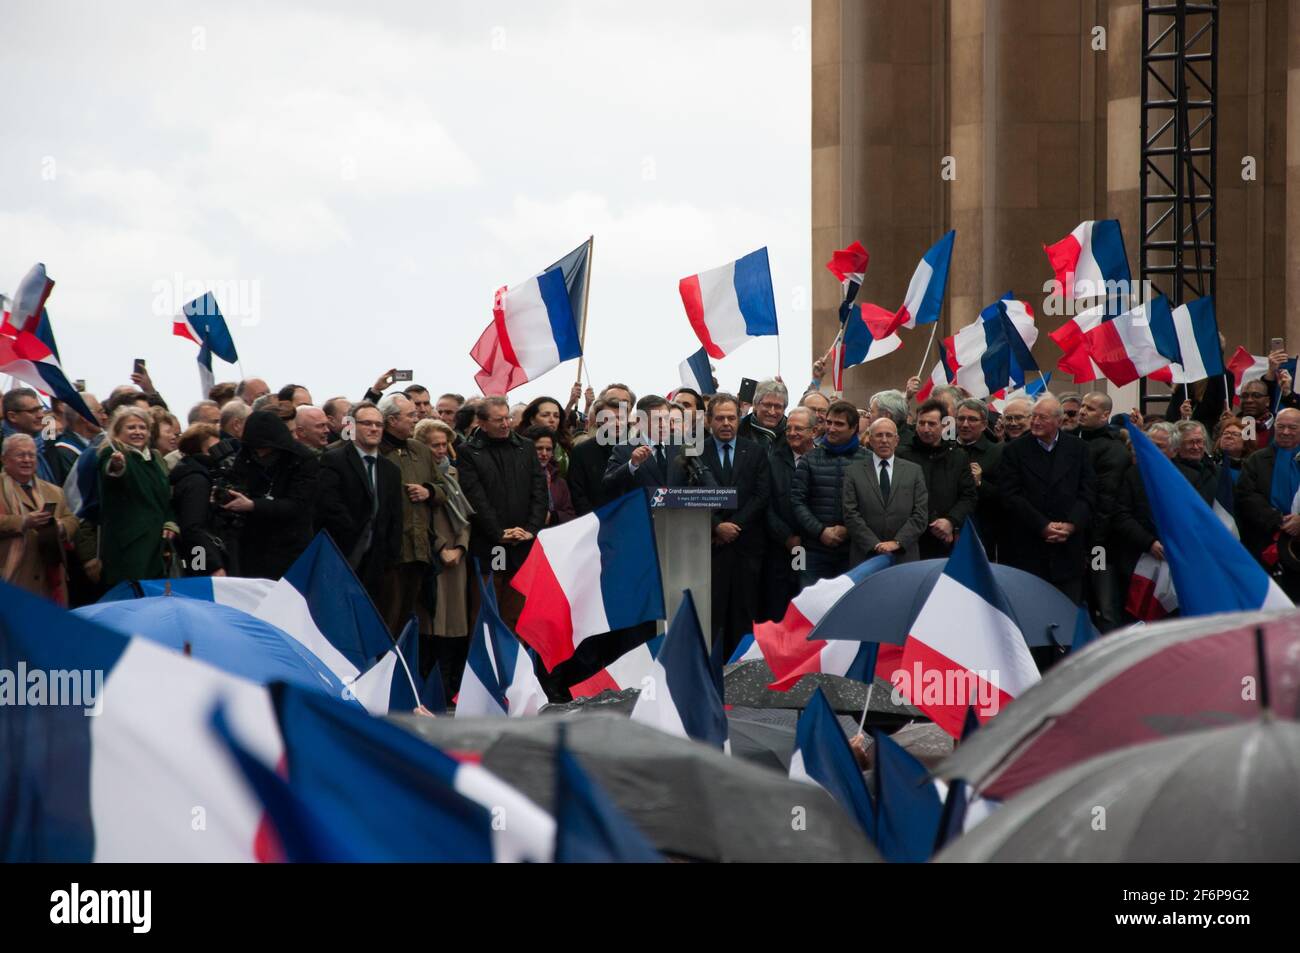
(1125, 419, 1291, 616)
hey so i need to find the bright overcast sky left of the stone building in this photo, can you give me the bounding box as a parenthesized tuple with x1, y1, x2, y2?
(0, 0, 811, 411)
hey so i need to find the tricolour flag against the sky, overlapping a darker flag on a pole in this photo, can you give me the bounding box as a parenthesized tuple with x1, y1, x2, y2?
(469, 267, 582, 394)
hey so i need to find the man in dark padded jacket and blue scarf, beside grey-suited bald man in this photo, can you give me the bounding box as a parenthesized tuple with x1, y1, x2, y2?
(790, 400, 868, 585)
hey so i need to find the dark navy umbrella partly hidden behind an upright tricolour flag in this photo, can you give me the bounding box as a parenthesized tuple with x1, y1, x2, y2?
(809, 559, 1079, 647)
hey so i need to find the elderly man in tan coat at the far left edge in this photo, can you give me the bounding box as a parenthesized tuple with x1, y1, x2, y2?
(0, 433, 78, 605)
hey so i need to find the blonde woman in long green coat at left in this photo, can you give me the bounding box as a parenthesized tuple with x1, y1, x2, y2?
(98, 404, 177, 586)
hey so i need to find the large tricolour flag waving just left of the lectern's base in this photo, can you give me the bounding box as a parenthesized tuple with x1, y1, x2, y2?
(510, 490, 664, 671)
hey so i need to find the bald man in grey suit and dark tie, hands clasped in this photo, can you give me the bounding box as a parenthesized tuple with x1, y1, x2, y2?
(844, 417, 930, 566)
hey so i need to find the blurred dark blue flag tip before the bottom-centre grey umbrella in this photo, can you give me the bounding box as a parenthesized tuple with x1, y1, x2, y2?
(555, 732, 664, 863)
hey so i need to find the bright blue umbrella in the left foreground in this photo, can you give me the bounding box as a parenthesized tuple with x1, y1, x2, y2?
(74, 595, 343, 698)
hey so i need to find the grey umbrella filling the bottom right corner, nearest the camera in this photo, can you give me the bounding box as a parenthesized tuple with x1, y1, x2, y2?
(936, 716, 1300, 863)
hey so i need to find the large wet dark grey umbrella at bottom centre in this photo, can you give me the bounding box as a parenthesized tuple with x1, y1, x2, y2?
(390, 714, 880, 862)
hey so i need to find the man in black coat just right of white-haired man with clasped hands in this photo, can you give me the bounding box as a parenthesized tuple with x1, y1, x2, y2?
(1075, 390, 1131, 632)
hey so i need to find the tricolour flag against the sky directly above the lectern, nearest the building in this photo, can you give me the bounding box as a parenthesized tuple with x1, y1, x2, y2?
(677, 248, 776, 358)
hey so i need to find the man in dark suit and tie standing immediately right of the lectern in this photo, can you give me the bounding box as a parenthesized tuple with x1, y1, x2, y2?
(702, 394, 771, 657)
